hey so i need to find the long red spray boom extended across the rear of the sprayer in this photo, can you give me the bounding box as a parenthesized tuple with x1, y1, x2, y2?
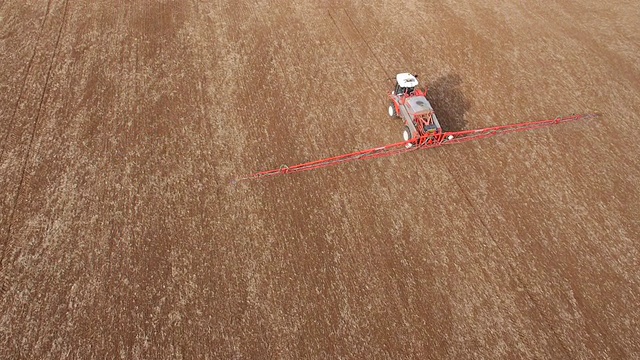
(236, 114, 599, 181)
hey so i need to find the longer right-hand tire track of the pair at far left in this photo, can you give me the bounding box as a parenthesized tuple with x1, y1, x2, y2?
(0, 0, 69, 296)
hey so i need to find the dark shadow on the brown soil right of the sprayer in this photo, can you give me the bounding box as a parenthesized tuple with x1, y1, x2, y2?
(427, 74, 471, 131)
